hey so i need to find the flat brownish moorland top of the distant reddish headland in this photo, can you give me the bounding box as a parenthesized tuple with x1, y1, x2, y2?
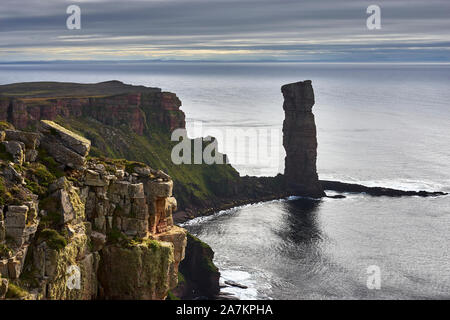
(0, 80, 161, 98)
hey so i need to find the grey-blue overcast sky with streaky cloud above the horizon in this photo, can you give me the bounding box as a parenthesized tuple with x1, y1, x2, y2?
(0, 0, 450, 63)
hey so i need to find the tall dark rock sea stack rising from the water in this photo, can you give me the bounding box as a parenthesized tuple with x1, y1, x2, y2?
(281, 80, 325, 197)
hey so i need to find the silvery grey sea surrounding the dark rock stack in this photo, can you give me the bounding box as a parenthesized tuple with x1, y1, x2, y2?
(0, 62, 450, 299)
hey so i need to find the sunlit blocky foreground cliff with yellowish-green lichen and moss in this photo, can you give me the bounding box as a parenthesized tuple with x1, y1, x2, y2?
(0, 121, 187, 299)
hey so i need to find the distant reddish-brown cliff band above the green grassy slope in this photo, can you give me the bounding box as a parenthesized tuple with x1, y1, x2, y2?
(0, 81, 185, 135)
